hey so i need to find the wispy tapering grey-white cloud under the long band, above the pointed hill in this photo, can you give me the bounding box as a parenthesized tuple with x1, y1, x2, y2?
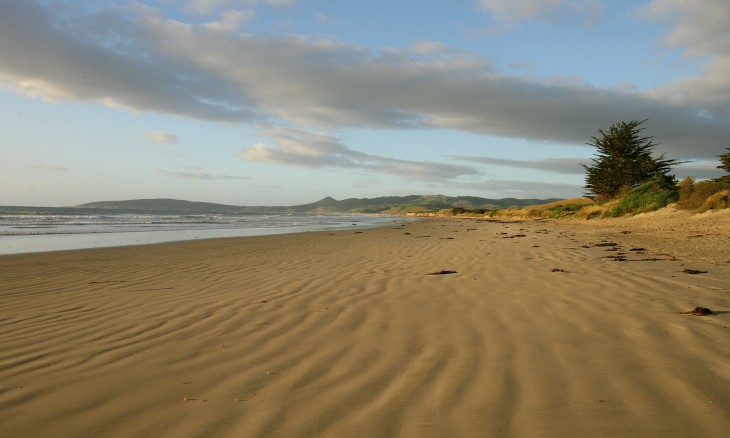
(239, 128, 478, 181)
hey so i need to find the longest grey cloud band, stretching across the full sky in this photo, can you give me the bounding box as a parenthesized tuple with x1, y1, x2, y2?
(0, 0, 730, 164)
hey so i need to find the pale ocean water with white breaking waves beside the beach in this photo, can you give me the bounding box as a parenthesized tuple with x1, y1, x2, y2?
(0, 206, 407, 254)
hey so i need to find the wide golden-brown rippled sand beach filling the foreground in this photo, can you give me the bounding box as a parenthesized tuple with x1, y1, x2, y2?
(0, 220, 730, 437)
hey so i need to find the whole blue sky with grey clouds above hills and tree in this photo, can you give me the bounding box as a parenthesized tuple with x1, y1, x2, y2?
(0, 0, 730, 206)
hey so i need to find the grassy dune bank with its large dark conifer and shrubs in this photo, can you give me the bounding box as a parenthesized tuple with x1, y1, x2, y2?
(452, 120, 730, 219)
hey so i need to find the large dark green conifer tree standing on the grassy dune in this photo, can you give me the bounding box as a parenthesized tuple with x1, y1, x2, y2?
(583, 120, 679, 200)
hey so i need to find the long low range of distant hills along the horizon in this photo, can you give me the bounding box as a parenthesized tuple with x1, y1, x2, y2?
(77, 195, 559, 214)
